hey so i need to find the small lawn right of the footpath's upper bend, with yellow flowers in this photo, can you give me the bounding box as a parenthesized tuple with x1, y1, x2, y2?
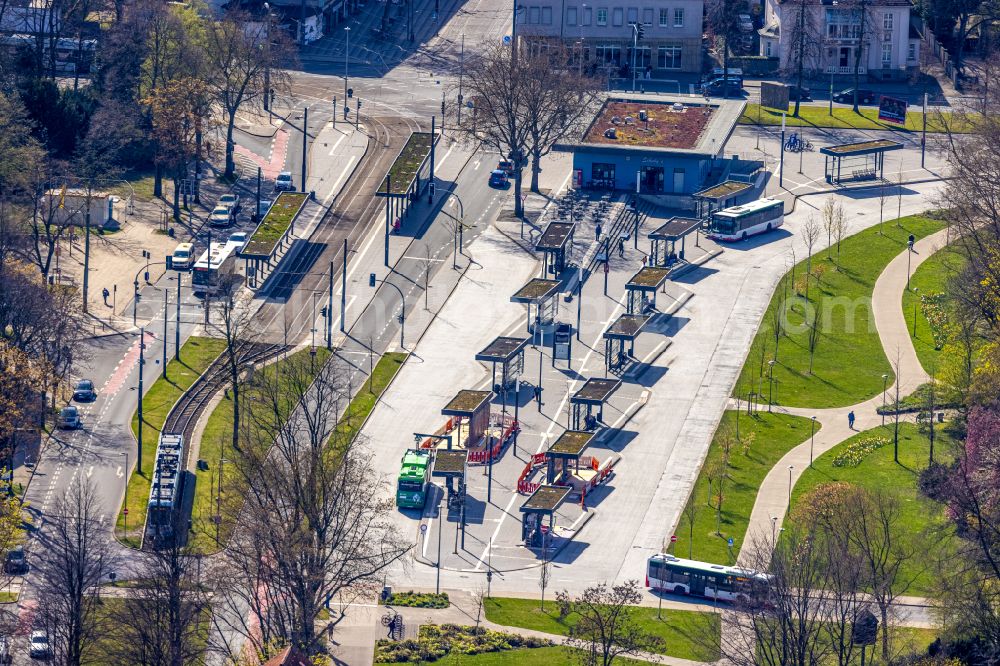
(902, 246, 965, 373)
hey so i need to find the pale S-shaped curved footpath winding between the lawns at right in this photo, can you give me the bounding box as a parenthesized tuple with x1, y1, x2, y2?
(737, 229, 948, 564)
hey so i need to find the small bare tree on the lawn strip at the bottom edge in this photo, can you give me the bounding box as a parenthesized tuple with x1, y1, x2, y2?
(561, 580, 663, 666)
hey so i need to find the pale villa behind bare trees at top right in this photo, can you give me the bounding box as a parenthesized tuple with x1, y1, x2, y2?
(759, 0, 921, 81)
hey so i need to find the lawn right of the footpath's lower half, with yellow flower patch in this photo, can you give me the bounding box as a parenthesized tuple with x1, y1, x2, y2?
(792, 418, 954, 596)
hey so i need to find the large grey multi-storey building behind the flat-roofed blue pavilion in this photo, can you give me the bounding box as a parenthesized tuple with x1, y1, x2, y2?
(517, 0, 704, 74)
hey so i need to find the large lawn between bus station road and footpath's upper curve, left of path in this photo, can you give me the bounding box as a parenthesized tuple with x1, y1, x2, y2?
(735, 213, 944, 407)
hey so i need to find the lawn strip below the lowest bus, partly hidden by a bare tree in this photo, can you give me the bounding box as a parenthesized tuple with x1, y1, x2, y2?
(483, 597, 721, 661)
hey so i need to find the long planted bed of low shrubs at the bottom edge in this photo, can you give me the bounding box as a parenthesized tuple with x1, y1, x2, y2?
(375, 624, 553, 664)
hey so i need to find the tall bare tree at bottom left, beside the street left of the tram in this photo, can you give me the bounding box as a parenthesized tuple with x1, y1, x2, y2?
(38, 477, 116, 666)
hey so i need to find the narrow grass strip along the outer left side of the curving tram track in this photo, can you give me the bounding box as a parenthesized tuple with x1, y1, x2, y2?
(115, 337, 226, 548)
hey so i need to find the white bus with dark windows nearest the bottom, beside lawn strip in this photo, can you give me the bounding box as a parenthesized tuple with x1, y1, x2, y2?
(646, 554, 768, 603)
